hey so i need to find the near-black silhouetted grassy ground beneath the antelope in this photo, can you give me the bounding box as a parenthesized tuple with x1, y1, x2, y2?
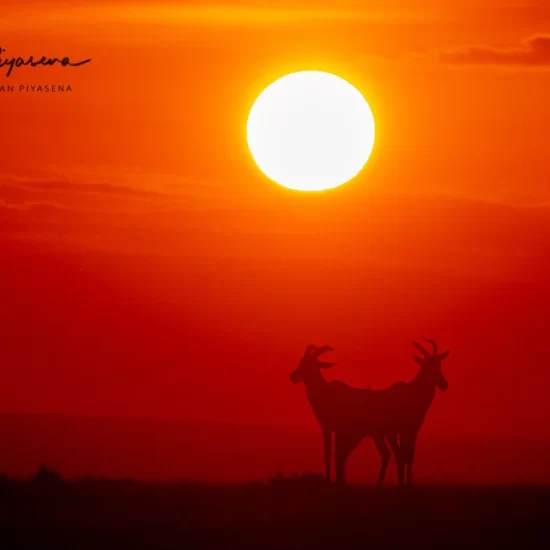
(0, 470, 550, 550)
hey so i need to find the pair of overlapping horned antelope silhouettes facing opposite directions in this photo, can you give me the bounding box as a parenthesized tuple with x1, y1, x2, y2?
(290, 340, 450, 485)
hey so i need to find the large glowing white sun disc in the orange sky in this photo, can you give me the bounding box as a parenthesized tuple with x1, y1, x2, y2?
(247, 71, 374, 191)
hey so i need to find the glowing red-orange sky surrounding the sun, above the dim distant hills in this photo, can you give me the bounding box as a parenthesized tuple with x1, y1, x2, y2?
(0, 0, 550, 484)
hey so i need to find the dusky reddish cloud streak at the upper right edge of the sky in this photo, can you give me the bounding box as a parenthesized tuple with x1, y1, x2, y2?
(439, 34, 550, 67)
